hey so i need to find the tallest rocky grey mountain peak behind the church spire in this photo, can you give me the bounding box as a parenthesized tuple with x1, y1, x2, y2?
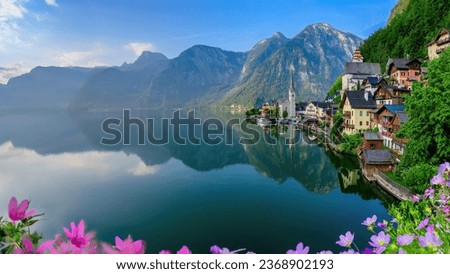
(221, 23, 362, 106)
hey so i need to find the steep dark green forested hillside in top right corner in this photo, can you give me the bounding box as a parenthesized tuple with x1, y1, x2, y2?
(360, 0, 450, 69)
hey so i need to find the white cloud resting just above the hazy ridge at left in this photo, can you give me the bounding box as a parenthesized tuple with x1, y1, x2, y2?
(55, 47, 108, 67)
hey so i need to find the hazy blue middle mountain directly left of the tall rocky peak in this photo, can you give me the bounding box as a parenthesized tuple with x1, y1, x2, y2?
(143, 45, 246, 106)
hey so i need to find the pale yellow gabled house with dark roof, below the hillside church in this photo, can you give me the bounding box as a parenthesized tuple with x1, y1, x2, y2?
(340, 90, 377, 135)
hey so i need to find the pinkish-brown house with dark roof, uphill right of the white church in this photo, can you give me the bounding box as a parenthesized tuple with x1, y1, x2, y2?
(386, 58, 422, 89)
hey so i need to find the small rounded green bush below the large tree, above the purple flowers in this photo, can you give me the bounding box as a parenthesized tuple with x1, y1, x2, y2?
(396, 164, 437, 193)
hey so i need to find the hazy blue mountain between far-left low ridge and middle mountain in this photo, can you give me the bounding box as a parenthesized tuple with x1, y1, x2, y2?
(70, 51, 169, 109)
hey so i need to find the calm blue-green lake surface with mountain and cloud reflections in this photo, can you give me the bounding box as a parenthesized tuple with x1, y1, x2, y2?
(0, 108, 392, 253)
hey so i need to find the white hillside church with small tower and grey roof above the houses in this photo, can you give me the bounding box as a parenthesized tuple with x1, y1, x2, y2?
(342, 49, 381, 91)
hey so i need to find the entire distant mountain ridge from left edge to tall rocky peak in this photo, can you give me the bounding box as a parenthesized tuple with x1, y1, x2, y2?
(0, 23, 362, 110)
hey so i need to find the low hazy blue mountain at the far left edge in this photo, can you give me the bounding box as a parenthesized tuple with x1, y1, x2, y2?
(0, 67, 96, 110)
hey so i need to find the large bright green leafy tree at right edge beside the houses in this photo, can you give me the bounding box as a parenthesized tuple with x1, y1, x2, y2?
(399, 50, 450, 170)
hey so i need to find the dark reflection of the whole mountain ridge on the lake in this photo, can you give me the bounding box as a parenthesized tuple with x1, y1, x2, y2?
(0, 111, 394, 200)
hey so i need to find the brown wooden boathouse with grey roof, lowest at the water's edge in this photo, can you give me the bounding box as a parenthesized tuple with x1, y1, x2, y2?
(360, 149, 396, 177)
